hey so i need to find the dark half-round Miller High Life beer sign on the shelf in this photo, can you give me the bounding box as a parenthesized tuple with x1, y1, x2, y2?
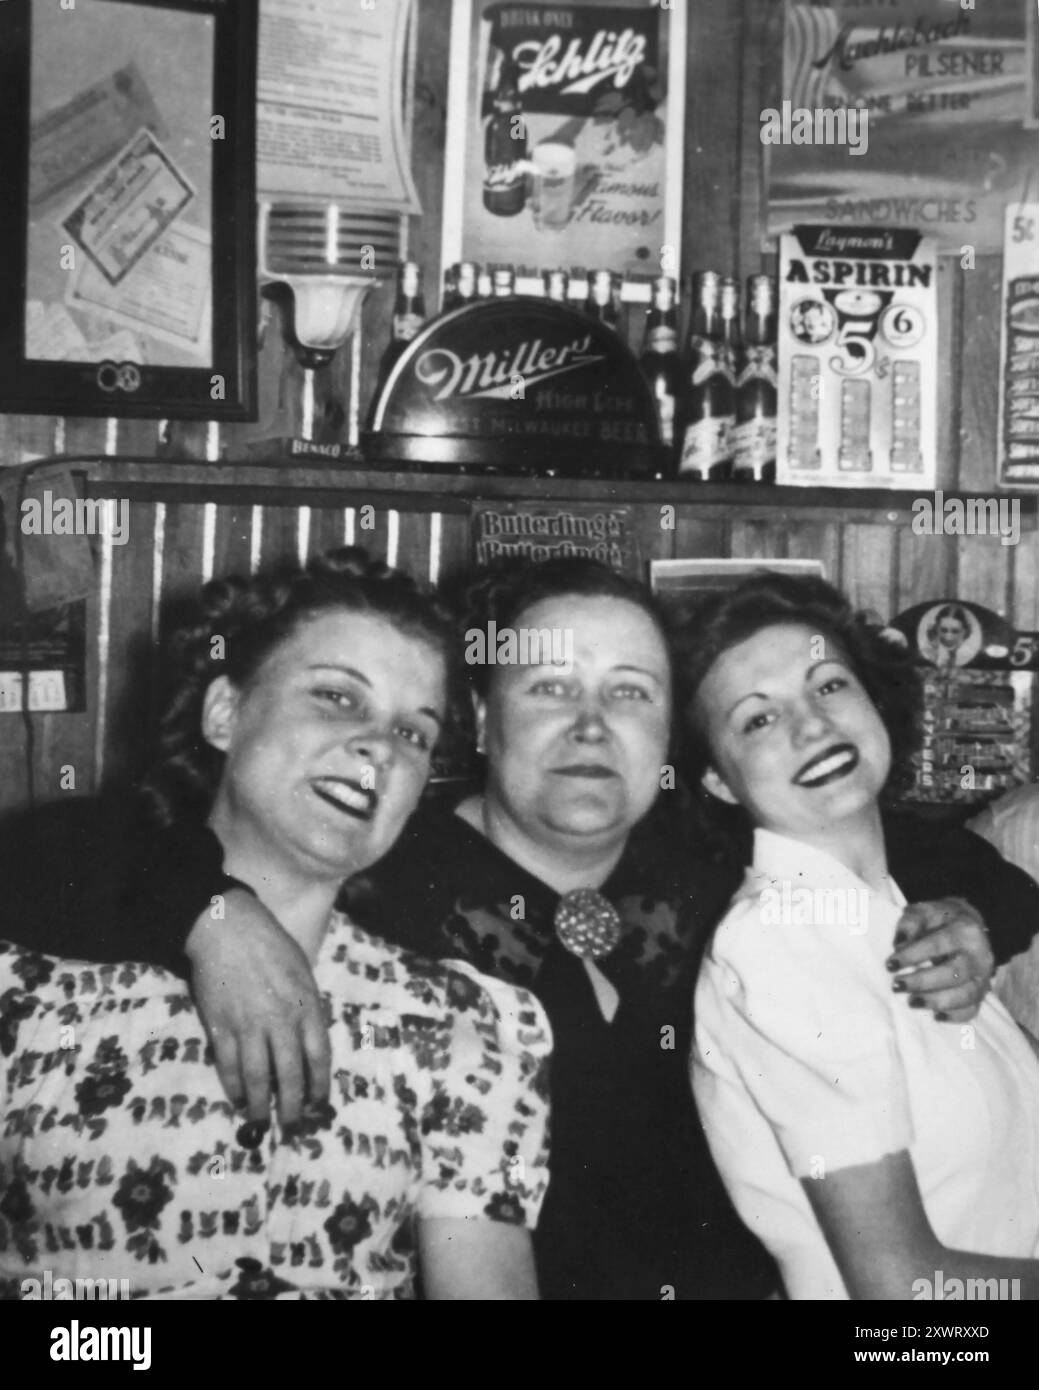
(363, 296, 665, 477)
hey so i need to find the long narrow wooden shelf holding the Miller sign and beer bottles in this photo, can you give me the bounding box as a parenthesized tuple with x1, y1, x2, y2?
(54, 457, 1039, 530)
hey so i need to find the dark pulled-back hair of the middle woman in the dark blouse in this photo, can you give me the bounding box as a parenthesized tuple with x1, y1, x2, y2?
(459, 555, 670, 696)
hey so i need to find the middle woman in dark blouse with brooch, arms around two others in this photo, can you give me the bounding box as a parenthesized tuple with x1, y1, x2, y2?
(4, 560, 1039, 1300)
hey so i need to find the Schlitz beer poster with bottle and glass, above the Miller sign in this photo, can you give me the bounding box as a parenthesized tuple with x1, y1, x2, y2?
(444, 0, 686, 299)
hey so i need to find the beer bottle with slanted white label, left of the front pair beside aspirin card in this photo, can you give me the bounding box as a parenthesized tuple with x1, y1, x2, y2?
(677, 270, 736, 482)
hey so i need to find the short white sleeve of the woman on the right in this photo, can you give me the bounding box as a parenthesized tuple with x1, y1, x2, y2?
(693, 898, 912, 1177)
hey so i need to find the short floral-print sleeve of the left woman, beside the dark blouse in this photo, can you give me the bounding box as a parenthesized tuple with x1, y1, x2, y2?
(419, 960, 552, 1227)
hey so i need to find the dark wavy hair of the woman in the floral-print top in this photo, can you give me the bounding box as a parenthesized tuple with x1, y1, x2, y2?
(142, 546, 456, 826)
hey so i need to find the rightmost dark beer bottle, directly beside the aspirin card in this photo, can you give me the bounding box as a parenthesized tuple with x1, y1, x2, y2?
(732, 275, 778, 482)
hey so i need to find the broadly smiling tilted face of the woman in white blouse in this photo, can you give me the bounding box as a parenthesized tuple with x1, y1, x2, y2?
(695, 624, 892, 840)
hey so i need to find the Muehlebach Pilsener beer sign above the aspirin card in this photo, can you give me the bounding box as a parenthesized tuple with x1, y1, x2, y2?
(762, 0, 1036, 254)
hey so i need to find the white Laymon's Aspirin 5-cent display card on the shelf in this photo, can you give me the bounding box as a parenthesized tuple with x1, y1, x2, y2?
(776, 227, 937, 491)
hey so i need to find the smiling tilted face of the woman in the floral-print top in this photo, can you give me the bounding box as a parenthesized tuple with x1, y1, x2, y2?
(203, 610, 445, 878)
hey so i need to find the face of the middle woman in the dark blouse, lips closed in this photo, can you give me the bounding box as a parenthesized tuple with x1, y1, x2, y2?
(477, 595, 670, 849)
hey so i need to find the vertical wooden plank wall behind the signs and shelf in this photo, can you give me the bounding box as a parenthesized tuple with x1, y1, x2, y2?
(0, 0, 1039, 808)
